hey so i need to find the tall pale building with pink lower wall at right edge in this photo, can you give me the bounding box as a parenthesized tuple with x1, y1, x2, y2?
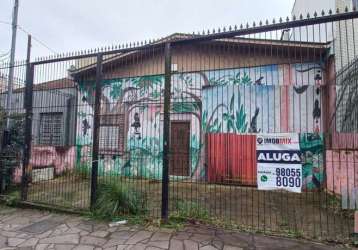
(291, 0, 358, 204)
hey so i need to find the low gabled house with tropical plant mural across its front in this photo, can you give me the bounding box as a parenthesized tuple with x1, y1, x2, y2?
(72, 34, 335, 188)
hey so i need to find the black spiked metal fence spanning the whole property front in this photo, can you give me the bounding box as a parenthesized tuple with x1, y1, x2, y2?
(0, 7, 358, 242)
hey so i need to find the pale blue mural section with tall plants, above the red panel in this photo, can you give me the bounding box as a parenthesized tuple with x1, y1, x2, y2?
(203, 85, 322, 133)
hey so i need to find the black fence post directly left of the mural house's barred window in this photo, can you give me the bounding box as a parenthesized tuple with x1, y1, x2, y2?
(91, 53, 103, 209)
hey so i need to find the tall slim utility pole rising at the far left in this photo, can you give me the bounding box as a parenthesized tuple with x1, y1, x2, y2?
(6, 0, 19, 130)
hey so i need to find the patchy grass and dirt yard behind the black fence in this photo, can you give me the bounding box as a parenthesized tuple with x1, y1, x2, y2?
(25, 175, 354, 242)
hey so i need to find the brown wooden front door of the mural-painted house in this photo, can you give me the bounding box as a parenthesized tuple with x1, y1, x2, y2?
(169, 121, 190, 176)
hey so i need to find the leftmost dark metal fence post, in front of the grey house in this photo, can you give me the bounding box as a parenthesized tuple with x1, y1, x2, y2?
(21, 35, 34, 201)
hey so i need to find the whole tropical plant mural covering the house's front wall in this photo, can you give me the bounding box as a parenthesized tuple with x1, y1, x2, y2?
(76, 61, 322, 179)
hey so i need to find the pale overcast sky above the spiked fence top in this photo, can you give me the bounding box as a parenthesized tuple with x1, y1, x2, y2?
(0, 0, 294, 59)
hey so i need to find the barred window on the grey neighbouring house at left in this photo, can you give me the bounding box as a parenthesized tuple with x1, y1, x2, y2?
(39, 113, 63, 146)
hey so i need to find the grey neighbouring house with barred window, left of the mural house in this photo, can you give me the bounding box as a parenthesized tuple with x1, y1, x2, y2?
(0, 78, 77, 146)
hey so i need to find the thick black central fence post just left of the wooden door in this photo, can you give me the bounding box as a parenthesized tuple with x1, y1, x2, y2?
(161, 43, 172, 221)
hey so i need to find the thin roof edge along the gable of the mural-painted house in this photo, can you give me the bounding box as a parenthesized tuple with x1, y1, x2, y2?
(71, 33, 328, 76)
